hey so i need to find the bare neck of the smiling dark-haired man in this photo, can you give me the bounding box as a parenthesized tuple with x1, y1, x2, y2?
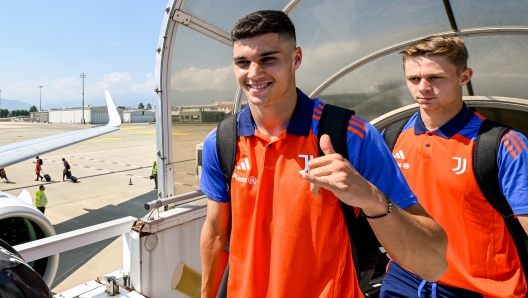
(248, 88, 297, 139)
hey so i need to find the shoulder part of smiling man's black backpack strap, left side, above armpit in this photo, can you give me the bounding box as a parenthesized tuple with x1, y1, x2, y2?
(216, 114, 237, 191)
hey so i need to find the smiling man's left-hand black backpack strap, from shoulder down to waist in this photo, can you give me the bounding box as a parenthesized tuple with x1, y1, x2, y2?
(216, 114, 237, 298)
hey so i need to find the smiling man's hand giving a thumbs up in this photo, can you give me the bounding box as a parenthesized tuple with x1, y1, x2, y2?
(301, 134, 379, 208)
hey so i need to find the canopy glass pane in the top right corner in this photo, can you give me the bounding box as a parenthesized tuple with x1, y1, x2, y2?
(450, 0, 528, 29)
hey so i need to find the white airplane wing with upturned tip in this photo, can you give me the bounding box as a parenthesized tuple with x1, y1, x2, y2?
(0, 90, 121, 168)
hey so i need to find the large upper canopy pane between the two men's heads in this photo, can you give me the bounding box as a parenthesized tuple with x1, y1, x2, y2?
(290, 0, 451, 94)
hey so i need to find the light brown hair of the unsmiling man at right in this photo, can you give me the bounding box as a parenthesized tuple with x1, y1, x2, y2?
(400, 36, 469, 71)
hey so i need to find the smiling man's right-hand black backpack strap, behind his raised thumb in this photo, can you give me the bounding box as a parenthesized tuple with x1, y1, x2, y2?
(318, 104, 379, 289)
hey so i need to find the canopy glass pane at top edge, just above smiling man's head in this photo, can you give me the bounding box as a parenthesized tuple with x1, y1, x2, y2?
(183, 0, 289, 32)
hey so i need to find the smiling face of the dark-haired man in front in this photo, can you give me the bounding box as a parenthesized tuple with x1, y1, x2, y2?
(233, 33, 302, 107)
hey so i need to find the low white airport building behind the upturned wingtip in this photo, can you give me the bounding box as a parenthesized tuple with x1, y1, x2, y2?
(48, 106, 124, 124)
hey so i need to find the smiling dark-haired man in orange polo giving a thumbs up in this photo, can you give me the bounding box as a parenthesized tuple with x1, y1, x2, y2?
(200, 11, 447, 297)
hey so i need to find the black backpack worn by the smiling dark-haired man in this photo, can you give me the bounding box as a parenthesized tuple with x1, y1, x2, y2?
(216, 104, 388, 297)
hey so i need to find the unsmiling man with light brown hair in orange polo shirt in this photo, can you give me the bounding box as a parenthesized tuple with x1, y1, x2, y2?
(381, 36, 528, 297)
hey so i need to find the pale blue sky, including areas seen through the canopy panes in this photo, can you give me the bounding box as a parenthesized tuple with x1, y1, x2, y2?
(0, 0, 527, 109)
